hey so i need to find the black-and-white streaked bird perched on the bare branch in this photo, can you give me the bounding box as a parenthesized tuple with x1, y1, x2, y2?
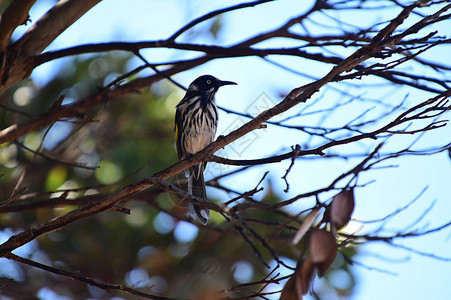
(174, 75, 237, 225)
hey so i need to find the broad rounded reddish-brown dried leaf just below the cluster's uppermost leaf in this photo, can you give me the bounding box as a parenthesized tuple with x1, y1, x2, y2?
(310, 230, 337, 276)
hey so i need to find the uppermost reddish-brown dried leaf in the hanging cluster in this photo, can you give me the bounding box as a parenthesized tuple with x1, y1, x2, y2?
(329, 189, 354, 230)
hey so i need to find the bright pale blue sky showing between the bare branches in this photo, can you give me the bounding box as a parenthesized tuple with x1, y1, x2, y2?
(7, 0, 451, 299)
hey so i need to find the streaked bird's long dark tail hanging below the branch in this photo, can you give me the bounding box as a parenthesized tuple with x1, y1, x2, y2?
(188, 164, 210, 225)
